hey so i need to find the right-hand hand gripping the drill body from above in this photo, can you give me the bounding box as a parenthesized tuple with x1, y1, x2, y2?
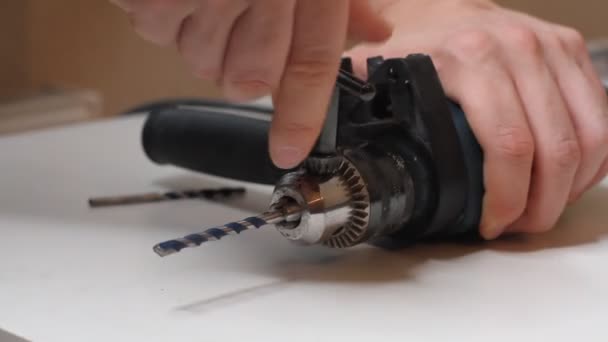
(348, 0, 608, 239)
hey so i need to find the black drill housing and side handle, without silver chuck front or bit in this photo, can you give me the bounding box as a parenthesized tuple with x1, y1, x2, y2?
(142, 54, 484, 248)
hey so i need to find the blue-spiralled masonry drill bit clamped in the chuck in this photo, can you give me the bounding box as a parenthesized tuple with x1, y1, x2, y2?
(153, 206, 301, 257)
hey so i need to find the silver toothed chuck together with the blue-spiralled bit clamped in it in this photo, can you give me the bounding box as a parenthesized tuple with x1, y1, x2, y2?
(153, 159, 374, 256)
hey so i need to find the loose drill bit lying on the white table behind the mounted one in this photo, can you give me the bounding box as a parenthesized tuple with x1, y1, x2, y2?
(89, 188, 245, 207)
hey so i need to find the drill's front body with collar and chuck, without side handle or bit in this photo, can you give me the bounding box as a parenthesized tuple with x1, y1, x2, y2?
(272, 55, 483, 247)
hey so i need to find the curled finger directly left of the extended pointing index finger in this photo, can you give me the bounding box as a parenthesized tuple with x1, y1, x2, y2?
(222, 0, 296, 101)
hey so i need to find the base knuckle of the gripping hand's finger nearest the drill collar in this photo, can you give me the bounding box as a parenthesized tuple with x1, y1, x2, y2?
(448, 29, 497, 63)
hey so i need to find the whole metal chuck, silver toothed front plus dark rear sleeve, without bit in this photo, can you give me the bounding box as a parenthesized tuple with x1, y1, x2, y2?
(271, 142, 415, 248)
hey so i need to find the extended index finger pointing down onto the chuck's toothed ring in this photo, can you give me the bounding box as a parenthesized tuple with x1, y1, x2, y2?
(270, 0, 348, 168)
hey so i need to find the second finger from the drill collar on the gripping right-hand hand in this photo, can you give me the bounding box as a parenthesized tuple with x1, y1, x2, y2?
(490, 25, 580, 232)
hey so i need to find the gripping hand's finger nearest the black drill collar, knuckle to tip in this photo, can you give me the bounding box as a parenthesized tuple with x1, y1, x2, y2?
(440, 31, 534, 239)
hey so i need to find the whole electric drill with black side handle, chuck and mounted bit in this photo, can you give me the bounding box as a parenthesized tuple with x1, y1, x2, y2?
(142, 54, 484, 256)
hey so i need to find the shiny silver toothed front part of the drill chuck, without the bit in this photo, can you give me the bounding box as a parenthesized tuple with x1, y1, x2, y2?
(271, 159, 370, 248)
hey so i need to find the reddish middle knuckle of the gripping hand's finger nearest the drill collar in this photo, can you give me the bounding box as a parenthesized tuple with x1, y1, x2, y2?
(494, 126, 534, 163)
